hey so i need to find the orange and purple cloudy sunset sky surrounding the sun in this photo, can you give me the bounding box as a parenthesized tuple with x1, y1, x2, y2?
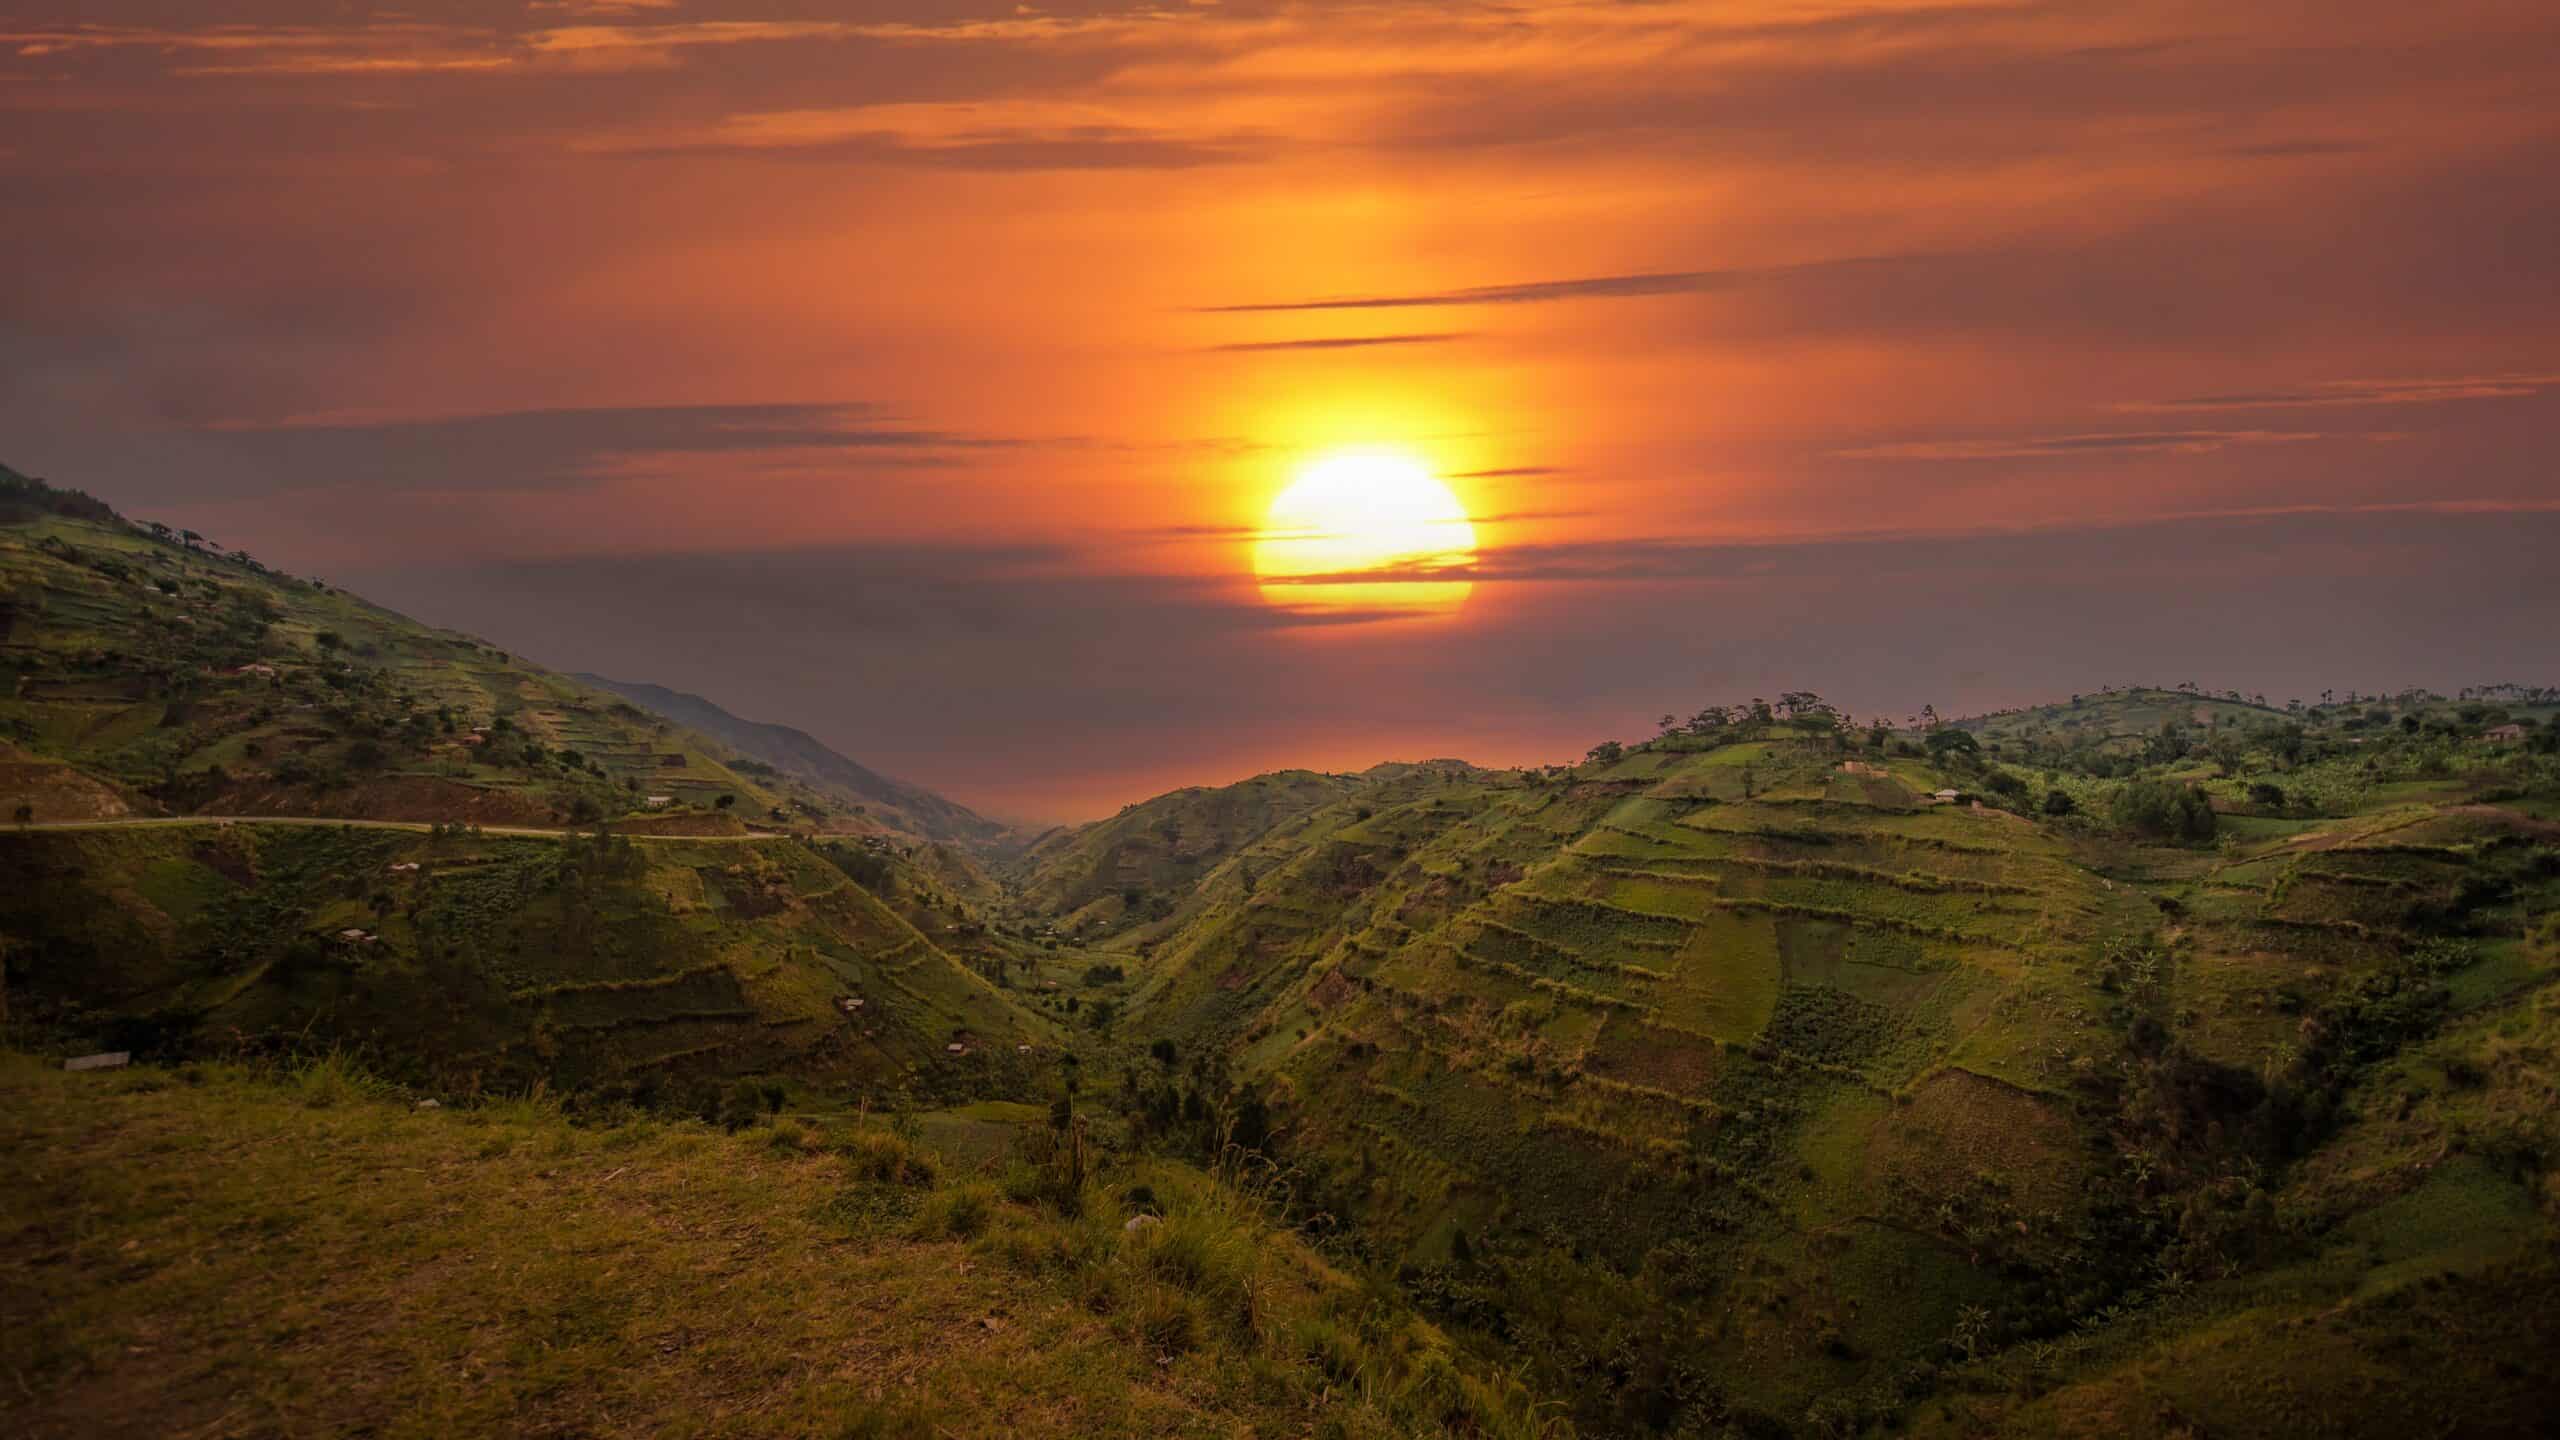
(0, 0, 2560, 817)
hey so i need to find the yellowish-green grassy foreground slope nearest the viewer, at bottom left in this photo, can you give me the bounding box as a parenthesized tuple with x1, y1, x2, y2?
(0, 1053, 1539, 1437)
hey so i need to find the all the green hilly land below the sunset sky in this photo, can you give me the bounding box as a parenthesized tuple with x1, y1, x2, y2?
(0, 474, 2560, 1437)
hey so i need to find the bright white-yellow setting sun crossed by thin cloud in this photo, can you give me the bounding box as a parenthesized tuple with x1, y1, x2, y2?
(1254, 451, 1475, 615)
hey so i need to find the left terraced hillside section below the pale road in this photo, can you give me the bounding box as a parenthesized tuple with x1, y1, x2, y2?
(0, 822, 1055, 1104)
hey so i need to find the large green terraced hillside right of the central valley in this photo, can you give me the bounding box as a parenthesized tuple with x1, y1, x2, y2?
(1105, 728, 2560, 1435)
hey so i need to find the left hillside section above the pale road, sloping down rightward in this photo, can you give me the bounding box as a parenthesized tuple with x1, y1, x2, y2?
(0, 474, 957, 838)
